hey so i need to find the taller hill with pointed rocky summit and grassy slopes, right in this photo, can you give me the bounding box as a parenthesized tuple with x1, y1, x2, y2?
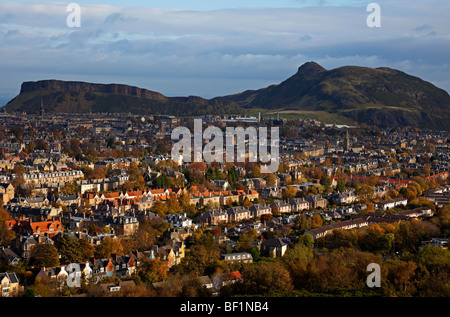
(214, 62, 450, 130)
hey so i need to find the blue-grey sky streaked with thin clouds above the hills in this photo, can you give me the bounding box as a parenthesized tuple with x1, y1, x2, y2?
(0, 0, 450, 106)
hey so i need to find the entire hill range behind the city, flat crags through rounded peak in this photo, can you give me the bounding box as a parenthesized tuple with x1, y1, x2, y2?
(5, 62, 450, 130)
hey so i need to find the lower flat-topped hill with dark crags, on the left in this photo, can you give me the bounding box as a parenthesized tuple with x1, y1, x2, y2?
(5, 80, 243, 115)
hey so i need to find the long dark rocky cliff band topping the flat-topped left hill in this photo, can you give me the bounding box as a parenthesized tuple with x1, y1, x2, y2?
(20, 80, 167, 101)
